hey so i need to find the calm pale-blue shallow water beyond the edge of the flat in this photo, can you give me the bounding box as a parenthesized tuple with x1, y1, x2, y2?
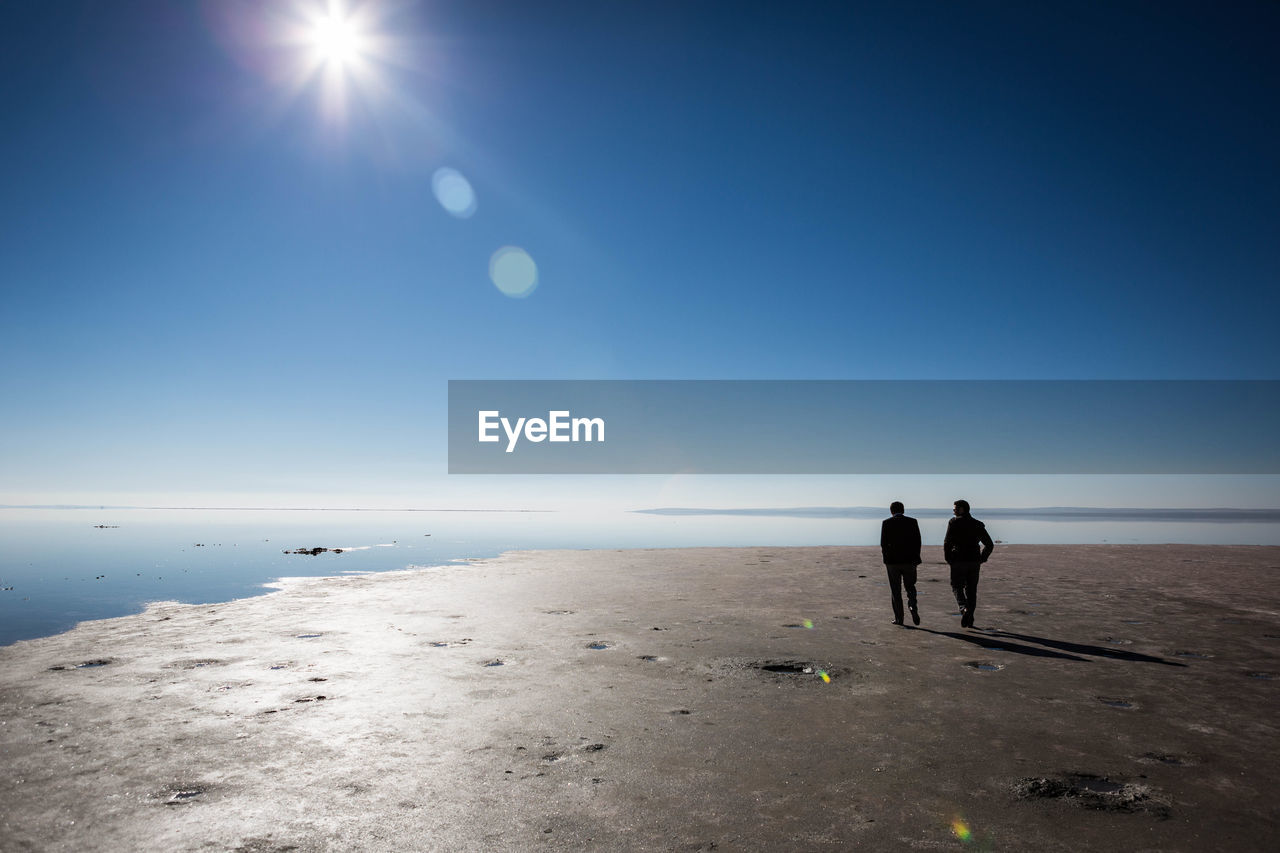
(0, 508, 1280, 644)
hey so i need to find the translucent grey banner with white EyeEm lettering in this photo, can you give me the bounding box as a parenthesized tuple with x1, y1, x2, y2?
(449, 379, 1280, 474)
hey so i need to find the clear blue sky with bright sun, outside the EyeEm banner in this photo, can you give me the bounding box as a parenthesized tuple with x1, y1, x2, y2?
(0, 0, 1280, 506)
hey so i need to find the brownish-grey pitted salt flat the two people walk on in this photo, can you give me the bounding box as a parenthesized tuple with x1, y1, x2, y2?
(0, 546, 1280, 852)
